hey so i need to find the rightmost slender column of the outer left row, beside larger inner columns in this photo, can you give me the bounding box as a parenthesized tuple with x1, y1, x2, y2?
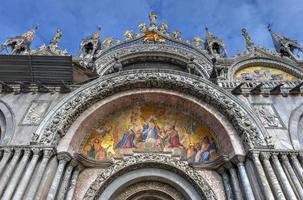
(25, 149, 53, 200)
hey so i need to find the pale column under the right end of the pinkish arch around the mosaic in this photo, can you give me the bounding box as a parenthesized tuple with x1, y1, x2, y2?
(237, 160, 255, 200)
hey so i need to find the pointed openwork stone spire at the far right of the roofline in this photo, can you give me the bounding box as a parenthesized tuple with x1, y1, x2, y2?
(267, 25, 303, 59)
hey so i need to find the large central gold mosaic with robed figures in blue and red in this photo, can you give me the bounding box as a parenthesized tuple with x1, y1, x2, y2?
(82, 105, 219, 163)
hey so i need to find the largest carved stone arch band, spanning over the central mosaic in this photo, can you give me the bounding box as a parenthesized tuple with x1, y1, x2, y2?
(33, 70, 267, 149)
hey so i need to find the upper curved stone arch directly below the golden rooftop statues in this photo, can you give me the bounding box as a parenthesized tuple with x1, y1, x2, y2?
(95, 42, 212, 79)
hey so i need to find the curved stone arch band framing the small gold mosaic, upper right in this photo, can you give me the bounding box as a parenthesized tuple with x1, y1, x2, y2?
(227, 58, 303, 81)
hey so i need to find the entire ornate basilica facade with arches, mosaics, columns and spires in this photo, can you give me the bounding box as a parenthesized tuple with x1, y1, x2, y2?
(0, 12, 303, 200)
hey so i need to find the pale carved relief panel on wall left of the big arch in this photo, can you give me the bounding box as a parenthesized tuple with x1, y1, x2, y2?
(20, 100, 50, 125)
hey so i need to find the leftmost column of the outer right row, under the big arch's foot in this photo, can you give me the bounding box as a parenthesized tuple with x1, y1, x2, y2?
(251, 152, 275, 200)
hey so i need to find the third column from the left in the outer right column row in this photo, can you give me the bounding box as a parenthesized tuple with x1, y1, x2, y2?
(271, 153, 297, 200)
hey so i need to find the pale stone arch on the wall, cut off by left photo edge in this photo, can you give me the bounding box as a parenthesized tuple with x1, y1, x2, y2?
(0, 101, 14, 145)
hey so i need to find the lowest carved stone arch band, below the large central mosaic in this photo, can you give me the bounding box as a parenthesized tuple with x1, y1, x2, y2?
(83, 153, 216, 200)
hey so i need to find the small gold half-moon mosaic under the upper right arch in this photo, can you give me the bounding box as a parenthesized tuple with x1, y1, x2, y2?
(235, 66, 297, 81)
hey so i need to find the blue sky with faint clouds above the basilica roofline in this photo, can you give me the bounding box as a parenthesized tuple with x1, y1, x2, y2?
(0, 0, 303, 55)
